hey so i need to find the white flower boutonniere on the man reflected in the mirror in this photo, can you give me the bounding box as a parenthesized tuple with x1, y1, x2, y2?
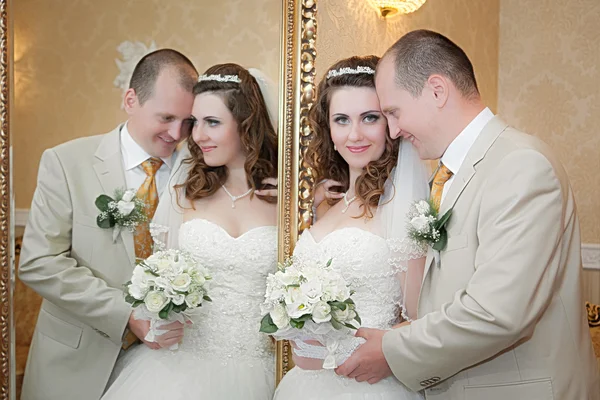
(96, 189, 148, 242)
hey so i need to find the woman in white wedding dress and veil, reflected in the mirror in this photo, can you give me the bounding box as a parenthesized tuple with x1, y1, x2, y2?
(102, 64, 277, 400)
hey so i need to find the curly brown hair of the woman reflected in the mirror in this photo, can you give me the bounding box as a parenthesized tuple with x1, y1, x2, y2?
(180, 63, 277, 203)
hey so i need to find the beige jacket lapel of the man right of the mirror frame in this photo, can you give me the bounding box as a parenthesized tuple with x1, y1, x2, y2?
(423, 116, 508, 281)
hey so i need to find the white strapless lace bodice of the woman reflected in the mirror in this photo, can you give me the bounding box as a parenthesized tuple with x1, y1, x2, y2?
(172, 219, 277, 363)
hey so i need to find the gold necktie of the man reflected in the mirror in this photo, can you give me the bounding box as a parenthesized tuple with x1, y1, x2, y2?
(134, 157, 163, 259)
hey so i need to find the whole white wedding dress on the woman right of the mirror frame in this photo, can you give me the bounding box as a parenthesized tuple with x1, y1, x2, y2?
(275, 228, 423, 400)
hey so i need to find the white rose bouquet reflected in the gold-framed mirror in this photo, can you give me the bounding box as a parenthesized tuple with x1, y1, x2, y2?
(125, 249, 212, 348)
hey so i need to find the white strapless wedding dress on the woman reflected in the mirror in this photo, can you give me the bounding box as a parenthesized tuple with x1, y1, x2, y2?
(102, 219, 277, 400)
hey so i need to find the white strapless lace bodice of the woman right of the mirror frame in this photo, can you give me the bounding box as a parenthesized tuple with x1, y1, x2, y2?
(294, 228, 402, 364)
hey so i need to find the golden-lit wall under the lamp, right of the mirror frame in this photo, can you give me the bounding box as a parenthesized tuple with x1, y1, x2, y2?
(316, 0, 499, 111)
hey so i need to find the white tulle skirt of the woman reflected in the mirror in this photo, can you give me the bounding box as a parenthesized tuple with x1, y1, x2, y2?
(101, 345, 275, 400)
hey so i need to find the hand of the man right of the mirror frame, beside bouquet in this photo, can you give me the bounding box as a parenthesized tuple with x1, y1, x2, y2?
(335, 328, 392, 384)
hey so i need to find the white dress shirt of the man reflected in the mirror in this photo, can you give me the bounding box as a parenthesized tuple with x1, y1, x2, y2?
(121, 123, 176, 197)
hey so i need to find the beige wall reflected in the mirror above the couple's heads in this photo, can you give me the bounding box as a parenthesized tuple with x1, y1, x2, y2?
(11, 0, 281, 208)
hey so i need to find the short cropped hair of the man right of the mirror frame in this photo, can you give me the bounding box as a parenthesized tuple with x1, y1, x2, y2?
(382, 29, 479, 99)
